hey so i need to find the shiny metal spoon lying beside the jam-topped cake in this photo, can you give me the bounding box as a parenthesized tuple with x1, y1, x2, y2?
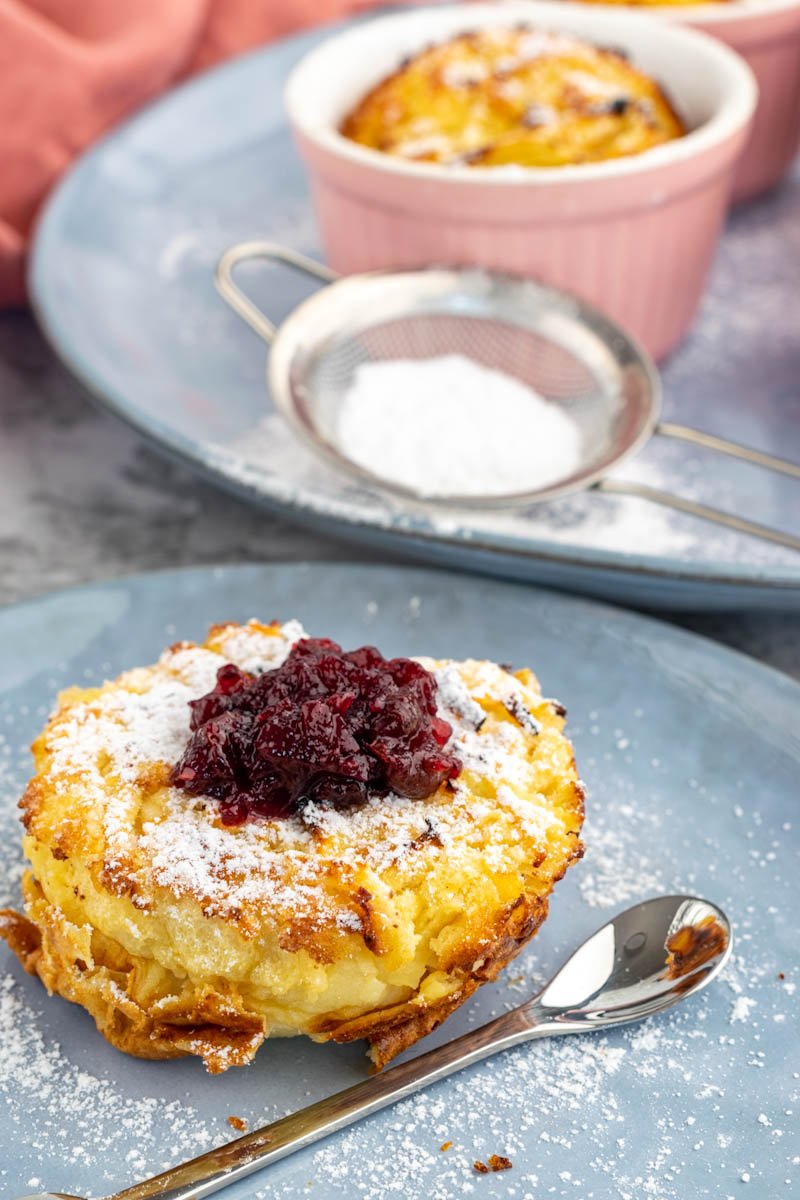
(22, 895, 733, 1200)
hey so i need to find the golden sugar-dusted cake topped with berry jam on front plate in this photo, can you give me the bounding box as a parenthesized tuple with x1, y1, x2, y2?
(0, 622, 583, 1072)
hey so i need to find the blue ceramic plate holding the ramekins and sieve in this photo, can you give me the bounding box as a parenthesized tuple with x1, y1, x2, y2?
(26, 21, 800, 608)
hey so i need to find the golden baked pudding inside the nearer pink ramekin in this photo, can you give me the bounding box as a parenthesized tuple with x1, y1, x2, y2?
(341, 26, 685, 167)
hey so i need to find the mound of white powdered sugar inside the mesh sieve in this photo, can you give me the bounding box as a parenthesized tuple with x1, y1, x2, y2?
(336, 354, 582, 497)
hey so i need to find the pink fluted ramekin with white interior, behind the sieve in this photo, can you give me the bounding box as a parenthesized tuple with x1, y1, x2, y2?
(287, 0, 756, 358)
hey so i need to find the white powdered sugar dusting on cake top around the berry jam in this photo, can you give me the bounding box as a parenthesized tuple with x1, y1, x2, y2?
(35, 622, 568, 930)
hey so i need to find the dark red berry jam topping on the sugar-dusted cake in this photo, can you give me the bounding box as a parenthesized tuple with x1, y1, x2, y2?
(172, 637, 461, 824)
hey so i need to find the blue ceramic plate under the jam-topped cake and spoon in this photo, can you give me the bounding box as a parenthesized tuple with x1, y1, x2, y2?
(0, 565, 800, 1200)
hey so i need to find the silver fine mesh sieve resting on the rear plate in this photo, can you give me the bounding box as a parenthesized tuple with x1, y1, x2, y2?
(216, 241, 800, 550)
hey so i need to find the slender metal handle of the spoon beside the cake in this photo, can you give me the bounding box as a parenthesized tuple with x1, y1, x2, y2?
(110, 1001, 568, 1200)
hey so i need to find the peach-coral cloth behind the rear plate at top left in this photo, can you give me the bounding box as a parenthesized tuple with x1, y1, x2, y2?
(0, 0, 383, 307)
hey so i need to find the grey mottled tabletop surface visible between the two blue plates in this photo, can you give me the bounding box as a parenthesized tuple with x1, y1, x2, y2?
(0, 313, 800, 678)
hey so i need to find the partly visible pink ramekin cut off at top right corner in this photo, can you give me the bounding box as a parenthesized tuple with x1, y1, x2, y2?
(594, 0, 800, 200)
